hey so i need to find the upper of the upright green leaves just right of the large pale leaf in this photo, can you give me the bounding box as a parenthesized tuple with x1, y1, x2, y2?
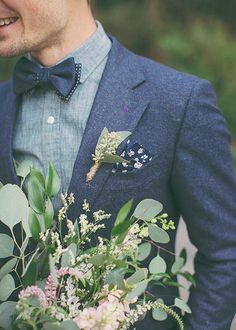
(28, 172, 45, 213)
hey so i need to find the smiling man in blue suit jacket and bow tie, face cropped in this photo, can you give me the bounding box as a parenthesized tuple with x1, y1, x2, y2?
(0, 0, 236, 330)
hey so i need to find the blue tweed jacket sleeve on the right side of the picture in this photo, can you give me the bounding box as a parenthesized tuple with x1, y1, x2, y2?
(171, 81, 236, 330)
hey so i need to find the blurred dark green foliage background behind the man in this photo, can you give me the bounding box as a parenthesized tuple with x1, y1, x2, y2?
(0, 0, 236, 164)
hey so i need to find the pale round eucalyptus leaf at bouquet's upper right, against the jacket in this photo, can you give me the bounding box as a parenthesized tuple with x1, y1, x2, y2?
(133, 199, 163, 221)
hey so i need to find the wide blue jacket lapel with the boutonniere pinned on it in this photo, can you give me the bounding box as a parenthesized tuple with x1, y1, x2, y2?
(69, 38, 150, 218)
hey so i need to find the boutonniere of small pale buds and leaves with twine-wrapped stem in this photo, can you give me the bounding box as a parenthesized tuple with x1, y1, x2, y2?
(86, 127, 131, 183)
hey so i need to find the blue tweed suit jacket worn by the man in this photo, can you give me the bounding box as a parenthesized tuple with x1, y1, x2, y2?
(0, 37, 236, 330)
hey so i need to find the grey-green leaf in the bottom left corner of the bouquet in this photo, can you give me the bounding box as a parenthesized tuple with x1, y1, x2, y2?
(0, 301, 17, 330)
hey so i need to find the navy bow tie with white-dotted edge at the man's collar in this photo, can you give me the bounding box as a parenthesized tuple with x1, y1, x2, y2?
(13, 57, 81, 102)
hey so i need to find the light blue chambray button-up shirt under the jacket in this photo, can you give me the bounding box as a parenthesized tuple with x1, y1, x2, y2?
(13, 22, 111, 208)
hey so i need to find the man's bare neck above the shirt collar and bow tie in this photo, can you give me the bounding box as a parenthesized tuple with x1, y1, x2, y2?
(32, 5, 97, 67)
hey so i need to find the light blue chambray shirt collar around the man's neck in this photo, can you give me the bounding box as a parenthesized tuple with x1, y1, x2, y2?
(28, 21, 112, 83)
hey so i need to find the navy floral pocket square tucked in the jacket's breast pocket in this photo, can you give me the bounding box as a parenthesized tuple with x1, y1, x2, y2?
(112, 141, 153, 173)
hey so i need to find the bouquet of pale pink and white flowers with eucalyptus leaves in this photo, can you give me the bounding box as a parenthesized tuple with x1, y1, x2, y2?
(0, 162, 195, 330)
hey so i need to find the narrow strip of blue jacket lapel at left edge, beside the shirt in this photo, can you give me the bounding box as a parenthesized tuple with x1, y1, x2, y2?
(0, 83, 19, 184)
